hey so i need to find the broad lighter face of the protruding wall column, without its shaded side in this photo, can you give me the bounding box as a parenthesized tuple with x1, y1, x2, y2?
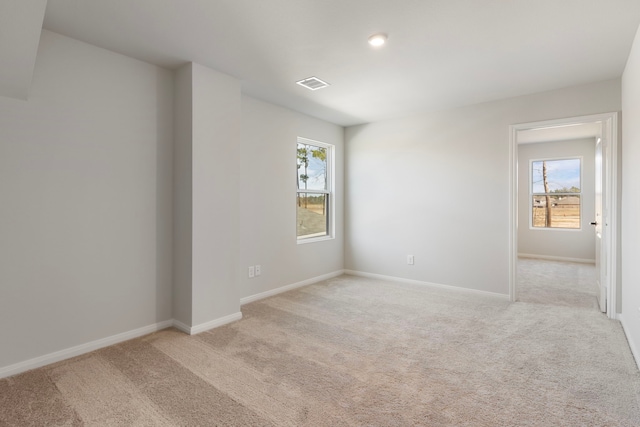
(191, 63, 240, 325)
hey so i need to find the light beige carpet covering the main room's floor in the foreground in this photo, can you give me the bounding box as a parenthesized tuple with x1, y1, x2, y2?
(0, 270, 640, 426)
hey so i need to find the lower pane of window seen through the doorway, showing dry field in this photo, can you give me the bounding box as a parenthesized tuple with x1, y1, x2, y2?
(532, 195, 580, 228)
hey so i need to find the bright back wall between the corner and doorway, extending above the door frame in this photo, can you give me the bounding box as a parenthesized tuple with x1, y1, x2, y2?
(345, 79, 621, 294)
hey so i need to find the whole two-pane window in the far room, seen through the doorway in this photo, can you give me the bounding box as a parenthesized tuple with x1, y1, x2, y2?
(530, 158, 582, 229)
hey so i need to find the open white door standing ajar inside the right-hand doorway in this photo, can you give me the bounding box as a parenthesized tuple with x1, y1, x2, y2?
(591, 138, 608, 313)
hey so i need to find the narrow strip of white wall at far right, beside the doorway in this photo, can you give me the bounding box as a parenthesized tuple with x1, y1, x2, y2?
(621, 25, 640, 364)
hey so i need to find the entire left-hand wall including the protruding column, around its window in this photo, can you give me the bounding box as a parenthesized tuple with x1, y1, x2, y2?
(0, 31, 344, 375)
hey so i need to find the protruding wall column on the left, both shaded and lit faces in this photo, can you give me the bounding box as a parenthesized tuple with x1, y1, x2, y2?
(173, 63, 241, 333)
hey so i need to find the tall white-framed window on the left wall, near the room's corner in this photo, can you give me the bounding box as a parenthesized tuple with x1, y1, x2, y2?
(296, 138, 333, 243)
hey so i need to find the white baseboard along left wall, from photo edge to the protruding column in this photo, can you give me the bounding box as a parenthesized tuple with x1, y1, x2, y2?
(0, 320, 174, 378)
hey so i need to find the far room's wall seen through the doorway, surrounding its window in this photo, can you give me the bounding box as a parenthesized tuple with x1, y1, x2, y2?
(518, 138, 596, 262)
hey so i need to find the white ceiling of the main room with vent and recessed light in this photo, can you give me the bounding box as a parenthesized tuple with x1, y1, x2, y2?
(12, 0, 640, 126)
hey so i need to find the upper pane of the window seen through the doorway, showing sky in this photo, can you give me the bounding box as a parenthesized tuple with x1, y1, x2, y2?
(531, 159, 580, 193)
